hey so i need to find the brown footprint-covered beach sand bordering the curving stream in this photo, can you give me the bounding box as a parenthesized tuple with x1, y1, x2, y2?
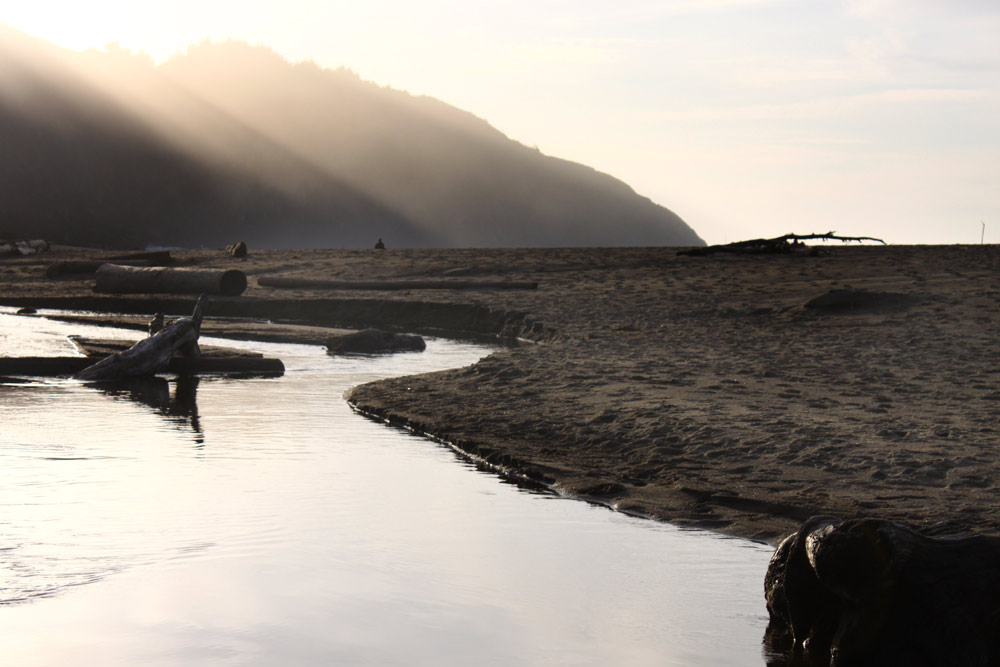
(0, 244, 1000, 541)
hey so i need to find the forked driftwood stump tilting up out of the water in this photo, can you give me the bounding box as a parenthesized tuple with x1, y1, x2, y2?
(74, 294, 208, 382)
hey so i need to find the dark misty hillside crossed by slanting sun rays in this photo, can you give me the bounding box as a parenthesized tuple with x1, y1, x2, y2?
(0, 27, 703, 247)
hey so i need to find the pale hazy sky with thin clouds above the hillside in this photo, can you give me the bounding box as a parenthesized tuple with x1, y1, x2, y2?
(0, 0, 1000, 243)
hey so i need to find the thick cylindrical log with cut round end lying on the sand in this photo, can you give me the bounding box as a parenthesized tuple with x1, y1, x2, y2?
(94, 264, 247, 296)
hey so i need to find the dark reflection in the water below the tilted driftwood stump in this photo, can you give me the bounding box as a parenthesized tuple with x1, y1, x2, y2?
(89, 375, 205, 447)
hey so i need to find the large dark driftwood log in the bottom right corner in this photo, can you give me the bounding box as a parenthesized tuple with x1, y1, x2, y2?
(764, 517, 1000, 667)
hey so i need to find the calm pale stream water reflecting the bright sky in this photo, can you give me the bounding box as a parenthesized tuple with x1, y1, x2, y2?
(0, 309, 771, 666)
